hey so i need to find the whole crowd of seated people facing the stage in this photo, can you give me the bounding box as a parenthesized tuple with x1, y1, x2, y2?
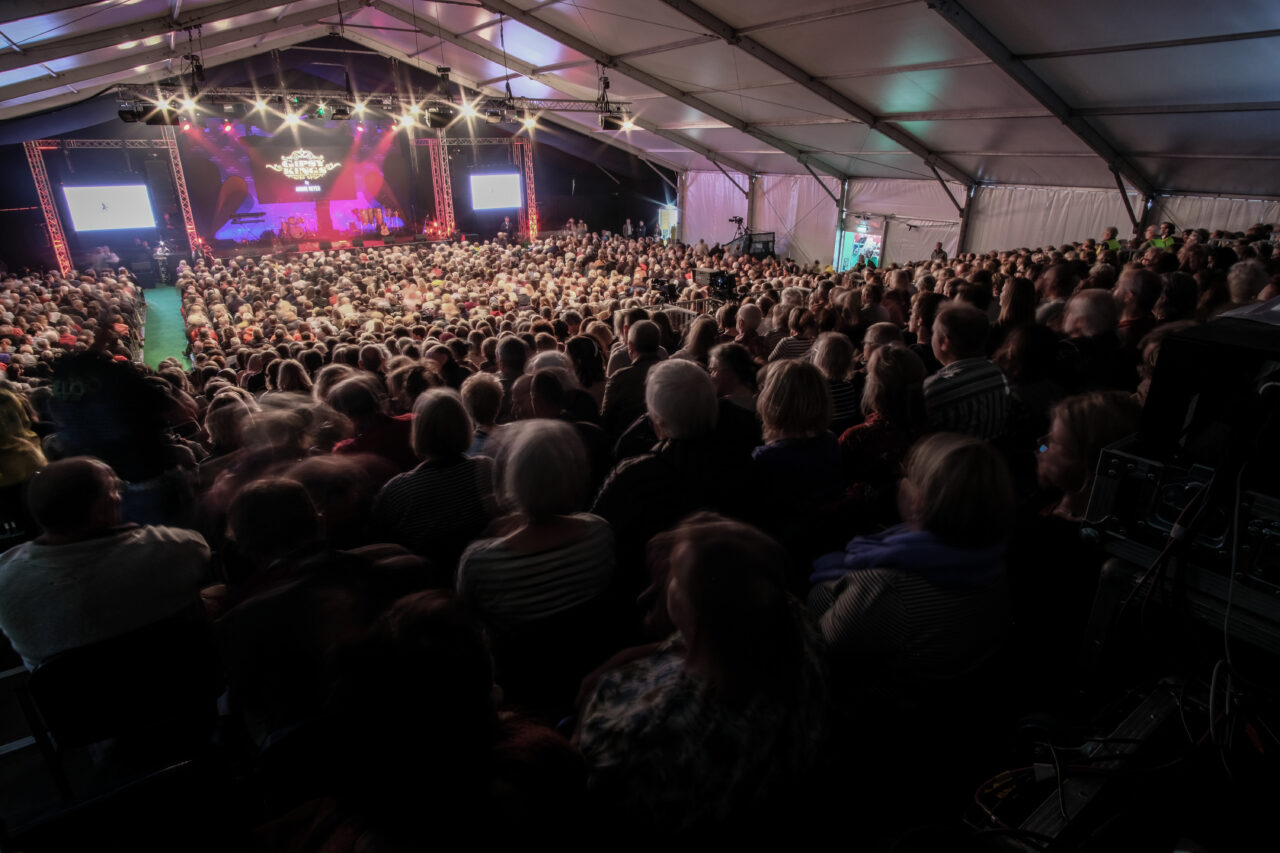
(0, 219, 1280, 852)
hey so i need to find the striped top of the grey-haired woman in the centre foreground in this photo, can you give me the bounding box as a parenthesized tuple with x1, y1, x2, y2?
(458, 512, 614, 625)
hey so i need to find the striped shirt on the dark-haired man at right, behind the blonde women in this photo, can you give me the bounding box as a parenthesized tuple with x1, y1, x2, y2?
(924, 359, 1009, 439)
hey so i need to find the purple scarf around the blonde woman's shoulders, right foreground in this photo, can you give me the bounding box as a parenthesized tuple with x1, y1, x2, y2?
(809, 524, 1005, 590)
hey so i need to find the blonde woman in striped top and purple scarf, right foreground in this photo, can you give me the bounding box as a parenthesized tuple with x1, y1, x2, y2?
(809, 433, 1015, 694)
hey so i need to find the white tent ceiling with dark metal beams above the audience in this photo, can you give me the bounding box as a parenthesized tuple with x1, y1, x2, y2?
(0, 0, 1280, 196)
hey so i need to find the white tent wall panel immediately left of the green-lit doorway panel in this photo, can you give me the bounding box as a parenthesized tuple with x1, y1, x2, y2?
(751, 174, 840, 266)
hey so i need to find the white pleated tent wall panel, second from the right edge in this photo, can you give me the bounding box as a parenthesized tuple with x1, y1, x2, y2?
(964, 187, 1142, 252)
